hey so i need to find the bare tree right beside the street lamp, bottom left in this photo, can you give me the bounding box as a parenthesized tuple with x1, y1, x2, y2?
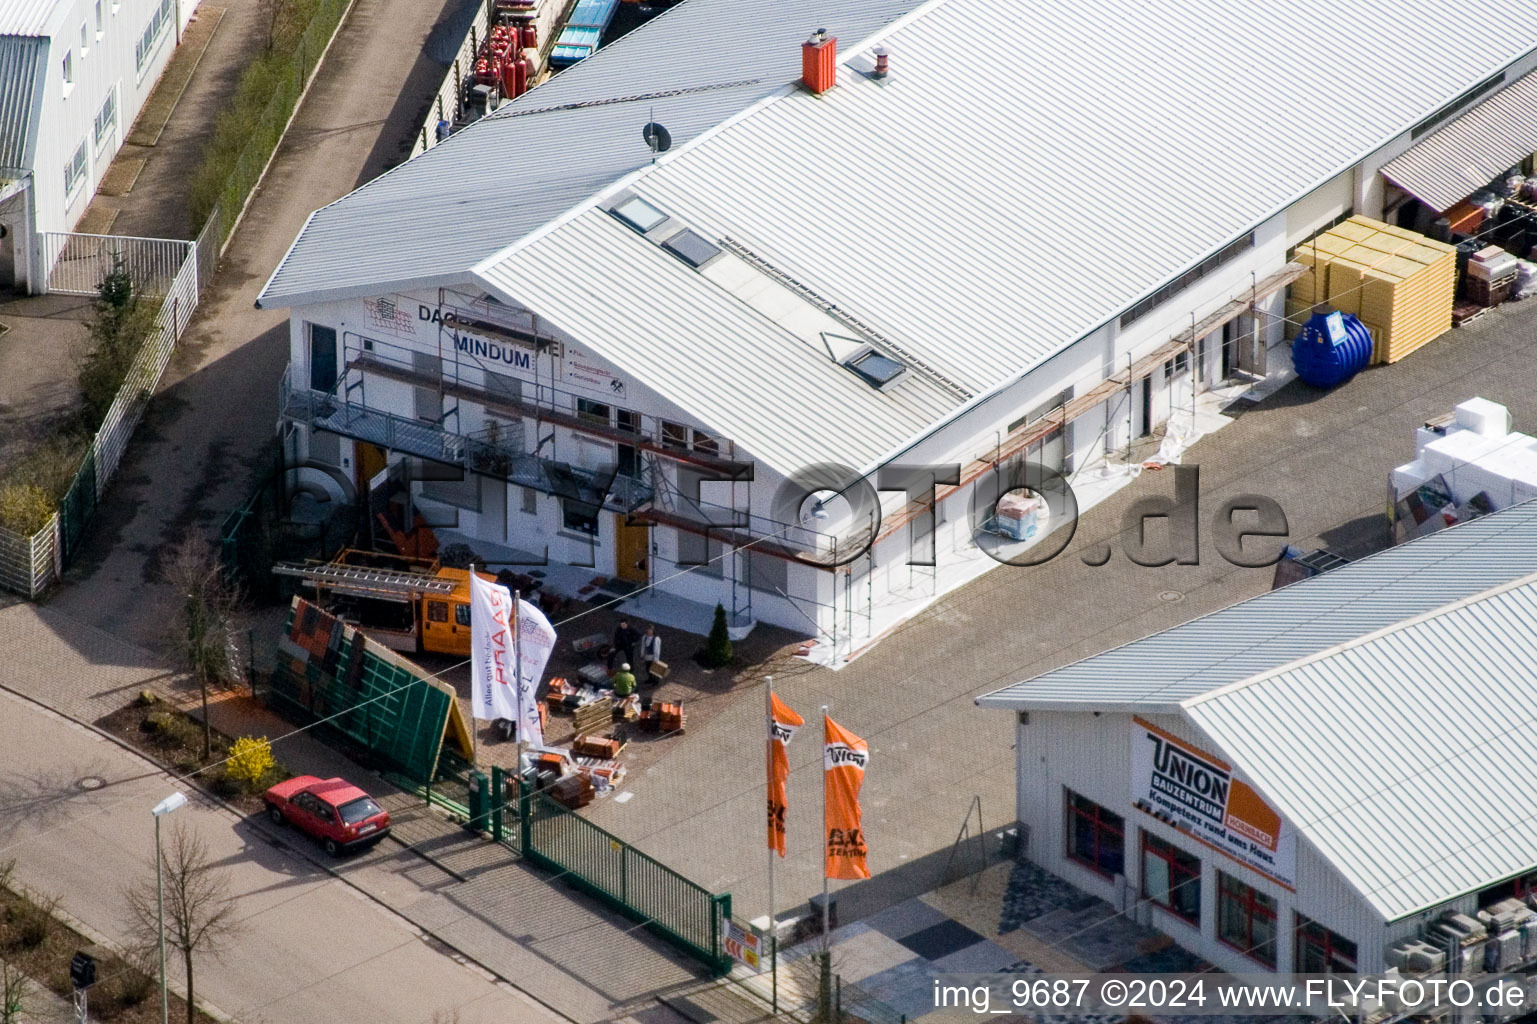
(124, 821, 240, 1024)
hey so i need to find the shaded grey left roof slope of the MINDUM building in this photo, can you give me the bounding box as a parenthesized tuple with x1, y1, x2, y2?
(261, 0, 919, 306)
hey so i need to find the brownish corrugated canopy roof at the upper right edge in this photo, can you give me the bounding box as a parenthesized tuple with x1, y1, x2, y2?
(1382, 72, 1537, 212)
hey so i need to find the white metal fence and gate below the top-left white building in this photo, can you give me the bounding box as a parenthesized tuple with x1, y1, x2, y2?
(0, 232, 198, 598)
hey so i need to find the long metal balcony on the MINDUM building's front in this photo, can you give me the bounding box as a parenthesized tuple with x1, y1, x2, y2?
(278, 372, 652, 512)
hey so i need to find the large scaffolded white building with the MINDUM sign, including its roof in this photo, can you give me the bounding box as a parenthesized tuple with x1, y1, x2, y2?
(260, 0, 1537, 661)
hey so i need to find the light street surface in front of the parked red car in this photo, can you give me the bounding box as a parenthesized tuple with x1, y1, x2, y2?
(0, 692, 564, 1024)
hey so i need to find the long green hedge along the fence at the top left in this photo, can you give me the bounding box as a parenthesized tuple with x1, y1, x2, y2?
(188, 0, 347, 235)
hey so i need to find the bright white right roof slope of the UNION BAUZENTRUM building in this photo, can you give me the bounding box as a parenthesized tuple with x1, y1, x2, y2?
(1185, 575, 1537, 921)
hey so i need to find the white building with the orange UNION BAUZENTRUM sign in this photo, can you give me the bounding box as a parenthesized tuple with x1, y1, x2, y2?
(978, 503, 1537, 973)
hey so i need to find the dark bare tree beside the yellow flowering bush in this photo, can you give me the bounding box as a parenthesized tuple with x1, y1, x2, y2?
(163, 537, 240, 761)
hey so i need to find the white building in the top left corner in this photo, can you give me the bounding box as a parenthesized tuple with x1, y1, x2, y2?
(0, 0, 198, 291)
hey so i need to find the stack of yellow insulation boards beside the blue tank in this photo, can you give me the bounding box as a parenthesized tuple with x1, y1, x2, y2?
(1286, 217, 1457, 363)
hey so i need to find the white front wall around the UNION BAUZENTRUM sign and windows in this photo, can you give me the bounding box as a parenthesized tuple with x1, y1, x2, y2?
(1016, 712, 1389, 973)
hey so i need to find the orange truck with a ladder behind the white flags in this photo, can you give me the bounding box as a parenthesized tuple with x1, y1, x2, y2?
(272, 549, 496, 655)
